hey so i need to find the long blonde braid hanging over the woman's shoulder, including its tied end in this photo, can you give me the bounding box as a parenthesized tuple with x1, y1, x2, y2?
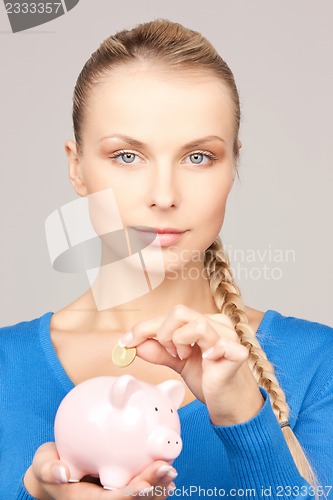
(205, 237, 317, 486)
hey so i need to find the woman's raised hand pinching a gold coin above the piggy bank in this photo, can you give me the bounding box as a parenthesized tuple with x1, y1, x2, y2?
(120, 305, 263, 425)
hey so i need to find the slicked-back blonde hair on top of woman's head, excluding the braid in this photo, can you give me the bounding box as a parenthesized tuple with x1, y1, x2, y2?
(73, 19, 240, 158)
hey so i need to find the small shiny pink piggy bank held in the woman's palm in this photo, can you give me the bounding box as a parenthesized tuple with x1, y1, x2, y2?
(54, 375, 185, 489)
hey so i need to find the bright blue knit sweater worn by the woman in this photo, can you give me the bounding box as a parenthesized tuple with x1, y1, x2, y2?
(0, 310, 333, 500)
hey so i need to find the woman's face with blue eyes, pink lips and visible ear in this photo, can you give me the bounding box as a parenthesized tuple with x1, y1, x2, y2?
(67, 66, 236, 276)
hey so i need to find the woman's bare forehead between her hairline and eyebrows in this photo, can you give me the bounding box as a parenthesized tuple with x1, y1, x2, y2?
(84, 66, 234, 143)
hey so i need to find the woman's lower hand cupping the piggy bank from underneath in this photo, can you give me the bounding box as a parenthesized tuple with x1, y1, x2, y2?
(24, 443, 177, 500)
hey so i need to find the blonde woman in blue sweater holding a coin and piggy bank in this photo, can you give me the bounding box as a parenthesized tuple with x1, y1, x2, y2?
(0, 20, 333, 500)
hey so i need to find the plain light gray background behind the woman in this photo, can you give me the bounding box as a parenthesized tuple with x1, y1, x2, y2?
(0, 0, 333, 325)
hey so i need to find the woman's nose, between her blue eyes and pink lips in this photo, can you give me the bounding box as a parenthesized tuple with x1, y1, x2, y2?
(148, 162, 179, 210)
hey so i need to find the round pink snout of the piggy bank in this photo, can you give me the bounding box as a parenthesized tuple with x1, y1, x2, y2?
(148, 428, 183, 460)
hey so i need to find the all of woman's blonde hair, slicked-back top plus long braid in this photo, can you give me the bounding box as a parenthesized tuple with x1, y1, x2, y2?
(73, 19, 316, 485)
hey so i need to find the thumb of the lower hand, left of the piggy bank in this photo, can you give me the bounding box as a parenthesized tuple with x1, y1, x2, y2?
(32, 443, 69, 484)
